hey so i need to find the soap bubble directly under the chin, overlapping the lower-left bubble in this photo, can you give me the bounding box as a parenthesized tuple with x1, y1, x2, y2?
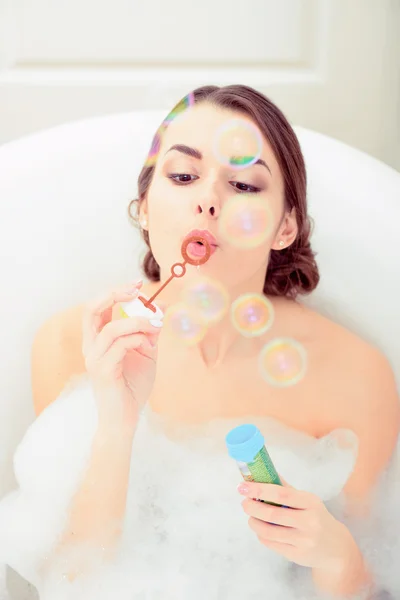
(182, 277, 229, 323)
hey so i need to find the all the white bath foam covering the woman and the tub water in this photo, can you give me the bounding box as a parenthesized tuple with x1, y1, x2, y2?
(0, 384, 400, 600)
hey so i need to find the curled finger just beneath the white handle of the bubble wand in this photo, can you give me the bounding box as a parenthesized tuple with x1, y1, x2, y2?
(88, 317, 161, 361)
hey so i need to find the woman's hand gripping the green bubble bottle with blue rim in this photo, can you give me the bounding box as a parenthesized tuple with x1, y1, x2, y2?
(238, 478, 355, 572)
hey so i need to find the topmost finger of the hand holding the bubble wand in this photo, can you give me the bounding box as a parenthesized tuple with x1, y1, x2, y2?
(82, 280, 143, 355)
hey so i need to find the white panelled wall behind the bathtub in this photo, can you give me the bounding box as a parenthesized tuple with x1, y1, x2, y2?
(0, 0, 400, 169)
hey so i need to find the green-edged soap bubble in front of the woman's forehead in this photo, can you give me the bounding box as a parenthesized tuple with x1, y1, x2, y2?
(214, 119, 263, 169)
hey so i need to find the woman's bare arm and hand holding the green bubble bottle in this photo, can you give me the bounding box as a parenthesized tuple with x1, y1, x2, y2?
(239, 351, 400, 596)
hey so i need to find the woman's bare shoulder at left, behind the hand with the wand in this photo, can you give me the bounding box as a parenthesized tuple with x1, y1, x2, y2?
(31, 305, 85, 415)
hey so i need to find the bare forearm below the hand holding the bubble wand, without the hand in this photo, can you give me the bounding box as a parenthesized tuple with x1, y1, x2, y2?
(44, 400, 135, 580)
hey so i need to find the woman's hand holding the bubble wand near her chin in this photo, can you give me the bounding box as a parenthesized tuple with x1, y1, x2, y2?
(82, 281, 161, 425)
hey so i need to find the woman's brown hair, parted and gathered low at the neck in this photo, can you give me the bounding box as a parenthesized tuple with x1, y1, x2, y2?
(128, 85, 319, 298)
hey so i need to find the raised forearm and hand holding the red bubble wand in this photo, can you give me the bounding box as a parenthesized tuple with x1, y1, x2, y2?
(32, 290, 160, 579)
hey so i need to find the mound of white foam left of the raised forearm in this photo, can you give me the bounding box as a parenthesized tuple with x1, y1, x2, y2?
(0, 381, 97, 586)
